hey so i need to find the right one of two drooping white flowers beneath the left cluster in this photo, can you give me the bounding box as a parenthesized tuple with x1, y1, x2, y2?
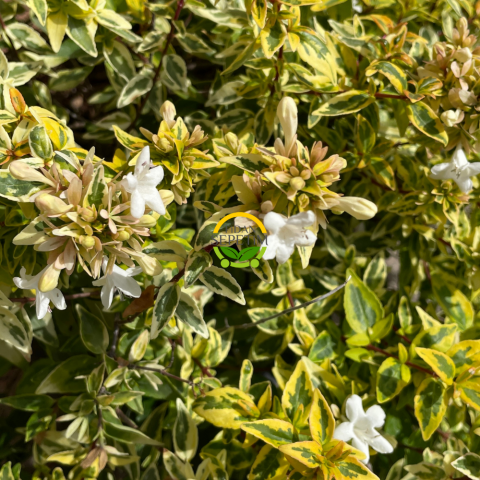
(92, 257, 142, 309)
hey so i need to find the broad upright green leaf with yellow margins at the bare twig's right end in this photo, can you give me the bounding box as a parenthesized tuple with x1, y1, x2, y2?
(343, 269, 384, 333)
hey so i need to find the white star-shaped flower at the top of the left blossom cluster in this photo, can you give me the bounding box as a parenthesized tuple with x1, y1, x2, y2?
(122, 147, 165, 218)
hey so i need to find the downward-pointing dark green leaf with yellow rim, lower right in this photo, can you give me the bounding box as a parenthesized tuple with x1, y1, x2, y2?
(415, 377, 448, 441)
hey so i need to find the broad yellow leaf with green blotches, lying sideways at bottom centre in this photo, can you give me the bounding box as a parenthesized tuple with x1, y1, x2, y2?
(193, 387, 260, 428)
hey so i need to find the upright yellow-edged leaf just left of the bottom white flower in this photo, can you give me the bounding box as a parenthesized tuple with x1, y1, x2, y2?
(282, 360, 313, 426)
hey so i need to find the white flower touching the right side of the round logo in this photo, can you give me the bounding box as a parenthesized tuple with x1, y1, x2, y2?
(262, 210, 317, 263)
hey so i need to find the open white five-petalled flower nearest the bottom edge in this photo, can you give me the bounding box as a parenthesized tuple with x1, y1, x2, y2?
(333, 395, 393, 463)
